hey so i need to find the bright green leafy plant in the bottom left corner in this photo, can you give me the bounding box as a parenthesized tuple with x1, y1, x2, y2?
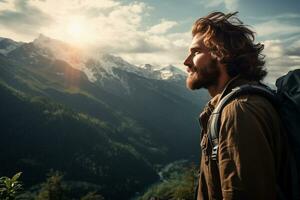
(0, 172, 22, 200)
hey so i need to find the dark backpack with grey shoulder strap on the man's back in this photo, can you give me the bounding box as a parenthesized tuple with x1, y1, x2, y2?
(209, 69, 300, 200)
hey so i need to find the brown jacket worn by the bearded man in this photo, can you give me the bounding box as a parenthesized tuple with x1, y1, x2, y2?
(197, 77, 288, 200)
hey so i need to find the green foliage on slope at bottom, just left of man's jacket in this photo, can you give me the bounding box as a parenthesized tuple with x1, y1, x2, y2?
(138, 166, 196, 200)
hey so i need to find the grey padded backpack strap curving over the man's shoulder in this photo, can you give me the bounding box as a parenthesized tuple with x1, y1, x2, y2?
(208, 84, 278, 160)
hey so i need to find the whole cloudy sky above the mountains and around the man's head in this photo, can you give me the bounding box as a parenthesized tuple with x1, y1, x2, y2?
(0, 0, 300, 83)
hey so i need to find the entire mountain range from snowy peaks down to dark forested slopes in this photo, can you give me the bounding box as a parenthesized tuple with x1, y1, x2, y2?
(0, 36, 207, 199)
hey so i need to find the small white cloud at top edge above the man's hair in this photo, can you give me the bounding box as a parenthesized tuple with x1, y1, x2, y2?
(200, 0, 239, 11)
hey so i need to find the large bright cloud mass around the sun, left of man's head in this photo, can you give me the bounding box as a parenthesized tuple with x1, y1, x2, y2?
(0, 0, 191, 68)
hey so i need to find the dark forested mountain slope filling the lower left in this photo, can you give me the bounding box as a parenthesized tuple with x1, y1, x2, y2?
(0, 82, 157, 199)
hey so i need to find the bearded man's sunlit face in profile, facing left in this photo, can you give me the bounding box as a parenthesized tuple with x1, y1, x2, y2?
(183, 33, 220, 90)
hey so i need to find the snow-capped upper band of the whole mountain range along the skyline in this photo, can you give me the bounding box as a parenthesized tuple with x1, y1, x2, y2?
(0, 34, 185, 82)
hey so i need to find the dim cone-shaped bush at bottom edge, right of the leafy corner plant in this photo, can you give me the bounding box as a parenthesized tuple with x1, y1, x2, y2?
(35, 171, 66, 200)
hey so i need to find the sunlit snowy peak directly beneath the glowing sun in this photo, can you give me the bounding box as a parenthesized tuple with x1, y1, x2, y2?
(33, 34, 157, 82)
